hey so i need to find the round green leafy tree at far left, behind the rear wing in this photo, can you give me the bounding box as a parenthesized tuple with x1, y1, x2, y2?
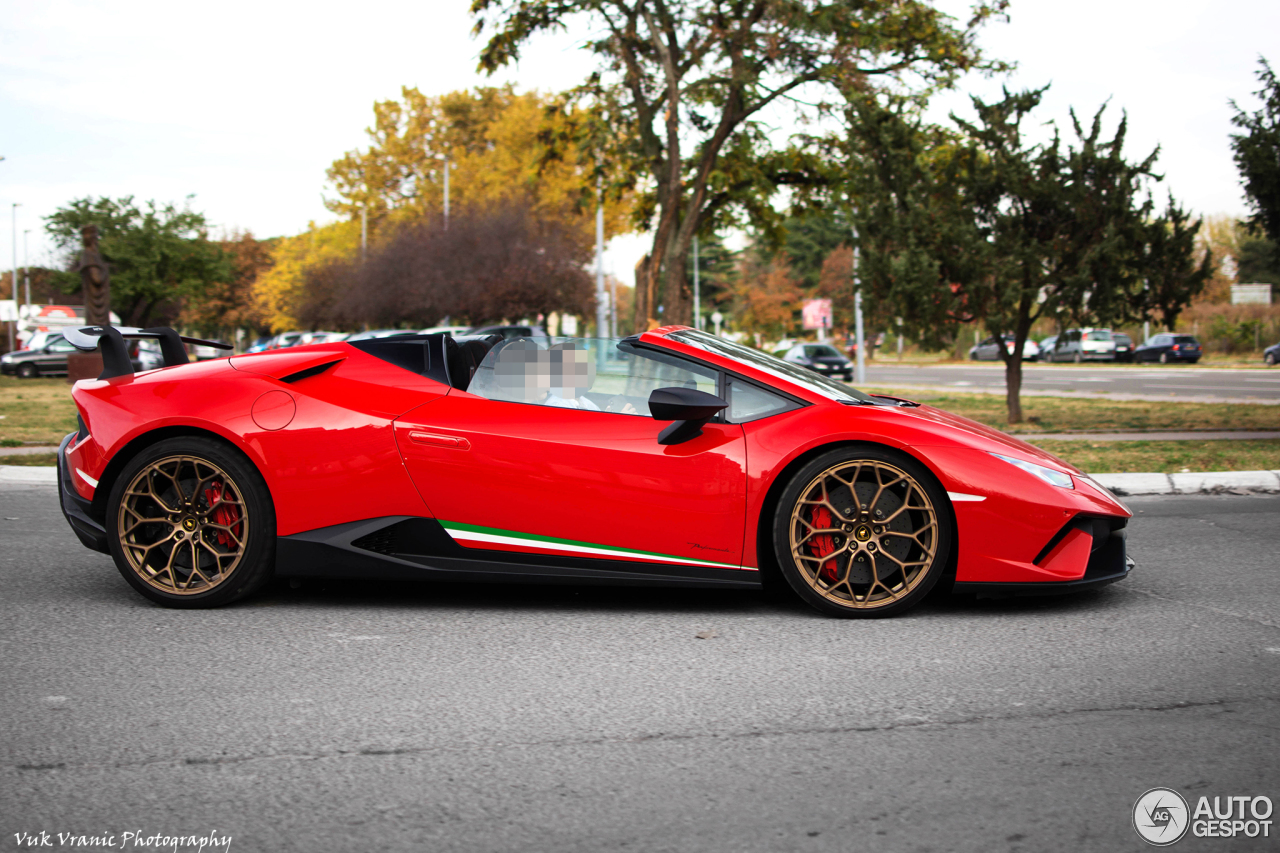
(45, 196, 232, 325)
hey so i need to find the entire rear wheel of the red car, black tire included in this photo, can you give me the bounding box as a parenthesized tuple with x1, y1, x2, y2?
(106, 435, 275, 608)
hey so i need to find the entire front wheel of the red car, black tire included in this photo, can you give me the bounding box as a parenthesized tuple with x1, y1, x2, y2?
(773, 444, 955, 619)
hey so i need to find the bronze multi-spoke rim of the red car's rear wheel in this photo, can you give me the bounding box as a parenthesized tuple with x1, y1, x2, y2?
(116, 453, 250, 596)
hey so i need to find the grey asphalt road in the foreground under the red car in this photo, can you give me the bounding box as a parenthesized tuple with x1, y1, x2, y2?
(0, 485, 1280, 853)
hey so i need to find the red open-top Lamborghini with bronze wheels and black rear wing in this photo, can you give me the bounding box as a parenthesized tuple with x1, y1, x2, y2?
(59, 327, 1133, 616)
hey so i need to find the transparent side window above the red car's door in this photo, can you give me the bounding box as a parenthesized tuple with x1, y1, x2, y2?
(467, 338, 718, 418)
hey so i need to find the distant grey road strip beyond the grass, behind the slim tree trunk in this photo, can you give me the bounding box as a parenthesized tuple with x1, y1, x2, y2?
(867, 361, 1280, 403)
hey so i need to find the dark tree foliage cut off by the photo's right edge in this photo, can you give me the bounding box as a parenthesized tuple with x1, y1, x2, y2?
(1230, 56, 1280, 258)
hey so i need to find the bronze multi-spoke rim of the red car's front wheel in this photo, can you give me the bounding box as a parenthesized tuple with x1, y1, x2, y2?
(787, 459, 945, 615)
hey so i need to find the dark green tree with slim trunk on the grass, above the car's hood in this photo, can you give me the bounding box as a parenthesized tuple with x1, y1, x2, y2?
(850, 88, 1182, 423)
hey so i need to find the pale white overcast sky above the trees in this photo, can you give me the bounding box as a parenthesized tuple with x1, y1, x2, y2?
(0, 0, 1280, 283)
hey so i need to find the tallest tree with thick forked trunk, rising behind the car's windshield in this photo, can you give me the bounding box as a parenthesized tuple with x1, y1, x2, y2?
(471, 0, 1006, 330)
